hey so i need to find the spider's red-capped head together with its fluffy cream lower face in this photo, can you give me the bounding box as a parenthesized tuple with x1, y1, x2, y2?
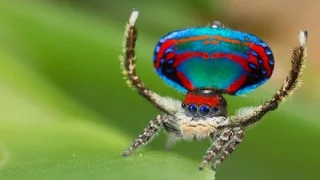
(163, 89, 229, 141)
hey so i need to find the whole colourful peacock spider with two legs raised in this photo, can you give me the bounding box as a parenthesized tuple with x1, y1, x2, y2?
(121, 9, 307, 170)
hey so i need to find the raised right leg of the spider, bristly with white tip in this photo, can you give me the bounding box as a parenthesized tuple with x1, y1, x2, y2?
(221, 31, 308, 128)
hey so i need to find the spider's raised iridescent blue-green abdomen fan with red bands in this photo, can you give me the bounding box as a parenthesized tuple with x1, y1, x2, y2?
(153, 26, 274, 95)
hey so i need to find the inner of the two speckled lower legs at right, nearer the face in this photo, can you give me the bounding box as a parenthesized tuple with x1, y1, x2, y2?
(199, 128, 233, 170)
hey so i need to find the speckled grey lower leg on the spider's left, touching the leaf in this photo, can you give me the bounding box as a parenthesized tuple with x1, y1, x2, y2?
(122, 115, 165, 157)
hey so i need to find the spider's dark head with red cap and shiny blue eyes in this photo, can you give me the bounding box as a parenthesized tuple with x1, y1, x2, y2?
(182, 89, 227, 119)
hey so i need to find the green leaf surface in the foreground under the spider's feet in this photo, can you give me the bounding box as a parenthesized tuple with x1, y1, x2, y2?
(0, 152, 214, 180)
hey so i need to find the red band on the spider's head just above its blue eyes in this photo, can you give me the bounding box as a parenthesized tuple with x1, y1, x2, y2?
(183, 92, 220, 108)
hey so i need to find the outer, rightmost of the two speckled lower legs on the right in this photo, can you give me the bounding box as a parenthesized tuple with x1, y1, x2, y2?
(211, 127, 244, 171)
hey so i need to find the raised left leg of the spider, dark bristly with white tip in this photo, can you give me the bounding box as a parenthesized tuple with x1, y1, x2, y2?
(120, 10, 181, 114)
